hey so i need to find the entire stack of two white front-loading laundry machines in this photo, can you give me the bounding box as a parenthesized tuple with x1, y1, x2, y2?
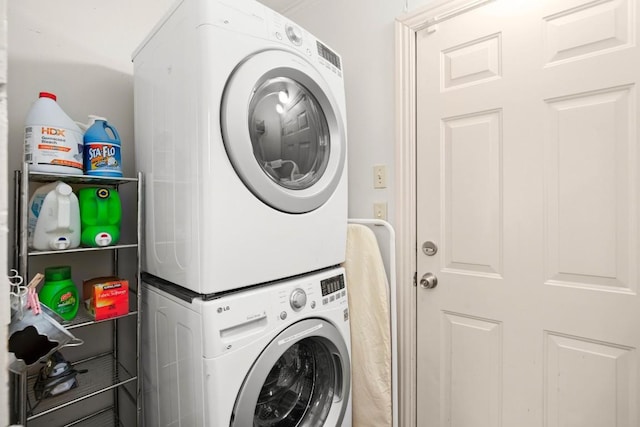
(133, 0, 351, 427)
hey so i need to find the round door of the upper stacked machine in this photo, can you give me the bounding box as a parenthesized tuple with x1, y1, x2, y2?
(220, 50, 346, 214)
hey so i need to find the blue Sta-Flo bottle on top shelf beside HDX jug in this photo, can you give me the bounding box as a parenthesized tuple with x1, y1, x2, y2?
(83, 117, 122, 177)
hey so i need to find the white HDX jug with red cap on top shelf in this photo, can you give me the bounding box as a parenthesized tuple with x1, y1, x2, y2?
(24, 92, 83, 175)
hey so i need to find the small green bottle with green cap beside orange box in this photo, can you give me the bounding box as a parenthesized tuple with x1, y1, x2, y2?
(38, 265, 80, 320)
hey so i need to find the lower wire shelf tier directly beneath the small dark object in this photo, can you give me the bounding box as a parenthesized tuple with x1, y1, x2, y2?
(27, 353, 137, 426)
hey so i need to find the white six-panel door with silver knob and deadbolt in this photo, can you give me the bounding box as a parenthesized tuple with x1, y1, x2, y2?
(416, 0, 640, 427)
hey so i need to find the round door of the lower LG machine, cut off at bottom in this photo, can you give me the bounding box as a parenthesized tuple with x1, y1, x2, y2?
(231, 319, 351, 427)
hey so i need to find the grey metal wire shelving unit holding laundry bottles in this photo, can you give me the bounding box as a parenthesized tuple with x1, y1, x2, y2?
(12, 169, 143, 427)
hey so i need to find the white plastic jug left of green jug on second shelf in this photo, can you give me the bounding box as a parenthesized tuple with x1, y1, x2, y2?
(27, 181, 80, 251)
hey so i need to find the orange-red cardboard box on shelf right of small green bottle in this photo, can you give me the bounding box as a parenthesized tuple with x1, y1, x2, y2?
(82, 276, 129, 320)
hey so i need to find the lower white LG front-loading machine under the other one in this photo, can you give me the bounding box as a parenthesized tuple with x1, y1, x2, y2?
(142, 268, 352, 427)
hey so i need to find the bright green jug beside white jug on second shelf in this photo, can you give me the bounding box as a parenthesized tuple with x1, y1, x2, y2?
(78, 187, 122, 247)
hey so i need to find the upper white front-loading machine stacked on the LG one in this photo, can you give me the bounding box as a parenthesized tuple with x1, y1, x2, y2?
(133, 0, 347, 294)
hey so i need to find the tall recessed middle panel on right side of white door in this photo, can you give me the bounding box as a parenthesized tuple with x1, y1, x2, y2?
(545, 86, 636, 289)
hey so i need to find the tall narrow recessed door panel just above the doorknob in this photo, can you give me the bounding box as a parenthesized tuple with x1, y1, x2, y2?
(443, 110, 502, 277)
